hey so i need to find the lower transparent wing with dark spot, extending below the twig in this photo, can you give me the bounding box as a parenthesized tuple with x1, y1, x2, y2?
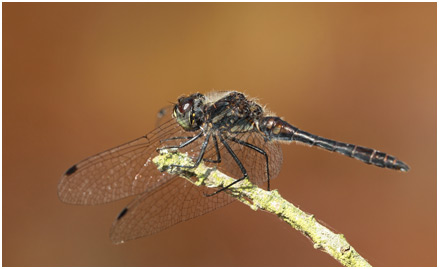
(110, 174, 234, 244)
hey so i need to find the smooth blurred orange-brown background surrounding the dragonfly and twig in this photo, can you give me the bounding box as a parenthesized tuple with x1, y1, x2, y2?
(3, 3, 437, 266)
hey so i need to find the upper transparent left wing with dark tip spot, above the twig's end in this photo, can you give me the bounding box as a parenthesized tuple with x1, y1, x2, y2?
(58, 119, 201, 205)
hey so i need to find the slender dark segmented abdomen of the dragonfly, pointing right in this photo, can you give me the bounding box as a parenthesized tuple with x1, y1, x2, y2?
(259, 117, 410, 172)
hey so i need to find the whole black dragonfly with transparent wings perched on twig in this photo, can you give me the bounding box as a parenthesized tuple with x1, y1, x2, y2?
(58, 91, 410, 244)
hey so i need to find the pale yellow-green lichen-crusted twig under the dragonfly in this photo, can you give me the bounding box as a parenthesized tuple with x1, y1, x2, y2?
(153, 150, 371, 267)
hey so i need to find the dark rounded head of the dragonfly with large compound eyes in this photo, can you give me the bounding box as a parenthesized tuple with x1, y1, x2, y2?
(172, 93, 206, 131)
